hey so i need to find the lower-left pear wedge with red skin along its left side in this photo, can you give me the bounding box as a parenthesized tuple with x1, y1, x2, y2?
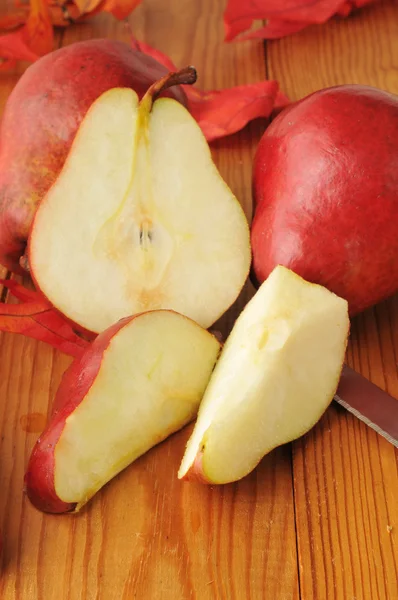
(25, 310, 220, 513)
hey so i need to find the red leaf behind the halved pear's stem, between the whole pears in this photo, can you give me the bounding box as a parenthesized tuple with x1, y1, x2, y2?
(132, 38, 289, 141)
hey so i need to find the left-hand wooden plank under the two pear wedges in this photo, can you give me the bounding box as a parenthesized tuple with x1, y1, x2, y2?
(0, 0, 298, 600)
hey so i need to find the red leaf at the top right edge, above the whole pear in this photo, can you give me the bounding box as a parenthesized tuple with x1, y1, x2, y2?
(224, 0, 377, 42)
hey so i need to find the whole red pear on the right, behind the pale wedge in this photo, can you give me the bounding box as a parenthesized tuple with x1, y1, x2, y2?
(251, 85, 398, 315)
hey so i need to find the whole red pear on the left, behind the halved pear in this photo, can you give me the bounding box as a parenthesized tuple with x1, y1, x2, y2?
(0, 39, 186, 272)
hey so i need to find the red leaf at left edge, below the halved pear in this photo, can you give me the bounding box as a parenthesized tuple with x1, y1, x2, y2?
(0, 279, 89, 356)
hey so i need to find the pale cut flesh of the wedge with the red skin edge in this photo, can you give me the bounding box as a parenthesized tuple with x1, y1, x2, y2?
(54, 311, 220, 507)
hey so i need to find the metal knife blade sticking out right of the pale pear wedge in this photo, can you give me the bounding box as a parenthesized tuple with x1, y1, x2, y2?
(334, 365, 398, 448)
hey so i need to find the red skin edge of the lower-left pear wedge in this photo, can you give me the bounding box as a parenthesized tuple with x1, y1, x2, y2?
(25, 315, 134, 513)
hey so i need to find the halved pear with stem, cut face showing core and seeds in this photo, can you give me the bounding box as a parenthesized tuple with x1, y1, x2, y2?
(29, 69, 251, 333)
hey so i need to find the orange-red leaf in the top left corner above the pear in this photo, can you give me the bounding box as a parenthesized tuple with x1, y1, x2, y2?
(0, 0, 53, 68)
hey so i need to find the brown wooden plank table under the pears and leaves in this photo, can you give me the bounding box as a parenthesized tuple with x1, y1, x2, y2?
(0, 0, 398, 600)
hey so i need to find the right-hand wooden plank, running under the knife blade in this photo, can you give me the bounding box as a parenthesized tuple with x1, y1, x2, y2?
(267, 1, 398, 600)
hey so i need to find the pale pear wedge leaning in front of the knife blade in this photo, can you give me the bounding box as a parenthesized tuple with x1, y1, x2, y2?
(178, 266, 349, 483)
